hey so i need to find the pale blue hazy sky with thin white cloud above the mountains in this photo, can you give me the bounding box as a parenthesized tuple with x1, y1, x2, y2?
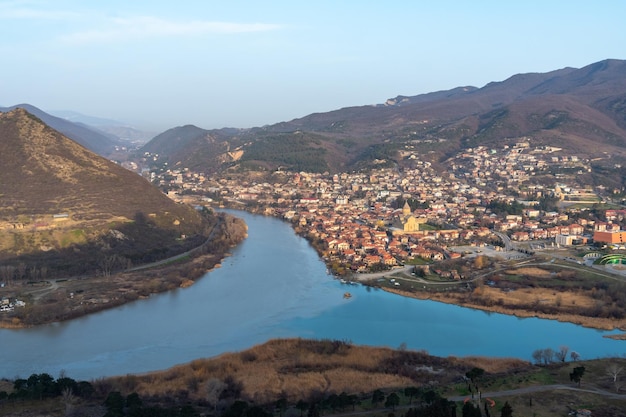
(0, 0, 626, 130)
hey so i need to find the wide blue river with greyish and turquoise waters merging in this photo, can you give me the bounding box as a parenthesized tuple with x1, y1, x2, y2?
(0, 212, 626, 380)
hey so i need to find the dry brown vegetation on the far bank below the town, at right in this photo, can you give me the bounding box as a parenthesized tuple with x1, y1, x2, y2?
(370, 255, 626, 330)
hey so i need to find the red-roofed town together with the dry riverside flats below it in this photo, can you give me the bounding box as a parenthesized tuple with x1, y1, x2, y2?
(139, 138, 626, 330)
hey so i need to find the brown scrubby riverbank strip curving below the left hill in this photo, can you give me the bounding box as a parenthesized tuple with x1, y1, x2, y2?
(0, 214, 247, 329)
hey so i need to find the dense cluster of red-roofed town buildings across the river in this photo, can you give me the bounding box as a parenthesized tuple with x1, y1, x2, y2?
(143, 140, 626, 271)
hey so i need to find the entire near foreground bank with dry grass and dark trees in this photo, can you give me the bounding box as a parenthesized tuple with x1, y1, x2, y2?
(0, 339, 626, 417)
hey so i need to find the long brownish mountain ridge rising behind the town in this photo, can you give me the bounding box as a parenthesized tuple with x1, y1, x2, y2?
(142, 59, 626, 171)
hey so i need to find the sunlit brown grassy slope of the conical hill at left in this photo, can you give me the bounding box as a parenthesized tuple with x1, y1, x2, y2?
(0, 109, 211, 280)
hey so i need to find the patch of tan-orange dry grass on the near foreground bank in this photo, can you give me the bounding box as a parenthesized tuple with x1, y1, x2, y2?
(112, 339, 529, 403)
